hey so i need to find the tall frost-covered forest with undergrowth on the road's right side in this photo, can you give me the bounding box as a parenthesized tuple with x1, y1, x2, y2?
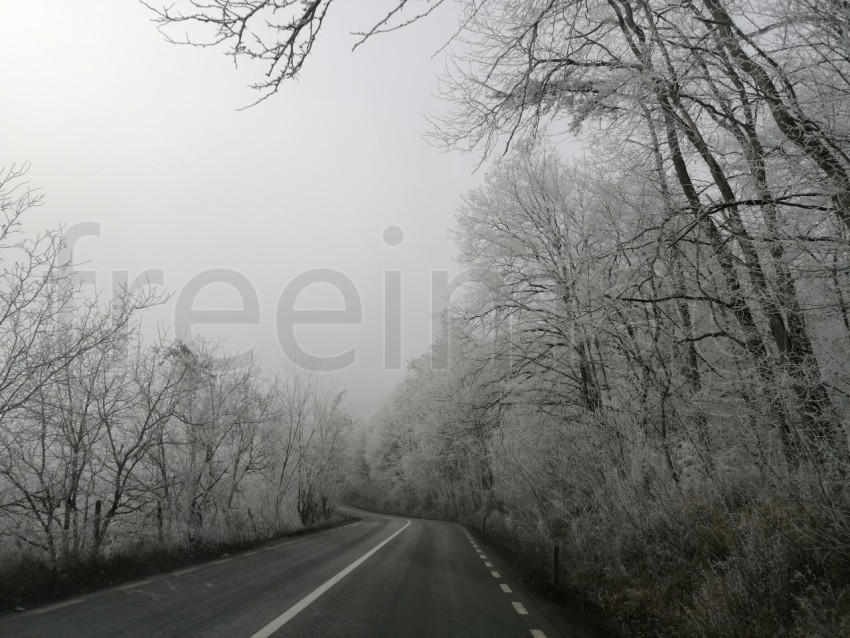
(330, 0, 850, 636)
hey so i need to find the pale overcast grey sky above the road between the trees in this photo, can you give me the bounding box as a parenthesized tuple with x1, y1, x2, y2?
(0, 0, 482, 415)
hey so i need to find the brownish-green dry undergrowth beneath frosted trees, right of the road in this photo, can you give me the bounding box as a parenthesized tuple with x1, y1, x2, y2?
(470, 490, 850, 638)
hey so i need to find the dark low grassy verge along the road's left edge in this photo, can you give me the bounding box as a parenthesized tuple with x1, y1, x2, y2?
(0, 516, 352, 614)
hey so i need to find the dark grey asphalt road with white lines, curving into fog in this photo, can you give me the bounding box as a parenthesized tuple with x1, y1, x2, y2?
(0, 510, 604, 638)
